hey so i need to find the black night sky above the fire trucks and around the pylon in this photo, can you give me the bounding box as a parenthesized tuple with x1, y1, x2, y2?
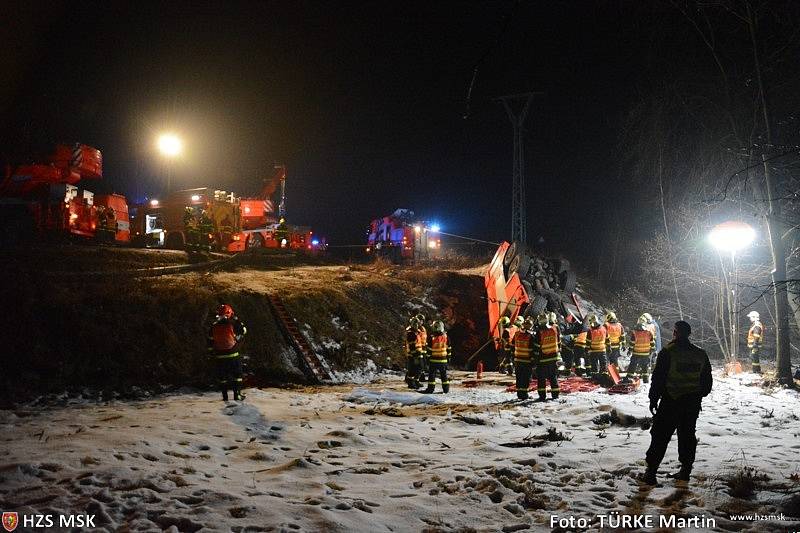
(0, 1, 688, 252)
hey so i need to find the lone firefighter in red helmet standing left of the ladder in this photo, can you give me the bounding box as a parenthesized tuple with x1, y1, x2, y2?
(208, 304, 247, 402)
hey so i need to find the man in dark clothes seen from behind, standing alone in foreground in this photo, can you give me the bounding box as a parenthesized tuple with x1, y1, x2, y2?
(642, 321, 713, 485)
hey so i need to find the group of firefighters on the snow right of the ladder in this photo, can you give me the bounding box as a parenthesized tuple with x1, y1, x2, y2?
(404, 304, 764, 401)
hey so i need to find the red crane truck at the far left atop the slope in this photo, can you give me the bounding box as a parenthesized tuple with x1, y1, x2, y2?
(0, 144, 130, 243)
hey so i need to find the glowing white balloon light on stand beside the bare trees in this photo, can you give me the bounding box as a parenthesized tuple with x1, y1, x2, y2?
(708, 220, 756, 364)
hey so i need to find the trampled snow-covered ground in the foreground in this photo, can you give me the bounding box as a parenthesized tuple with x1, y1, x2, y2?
(0, 373, 800, 532)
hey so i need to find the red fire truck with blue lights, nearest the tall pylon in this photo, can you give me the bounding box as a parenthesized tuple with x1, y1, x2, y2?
(366, 209, 442, 263)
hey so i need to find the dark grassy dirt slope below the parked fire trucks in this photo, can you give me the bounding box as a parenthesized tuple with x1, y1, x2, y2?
(0, 247, 486, 404)
